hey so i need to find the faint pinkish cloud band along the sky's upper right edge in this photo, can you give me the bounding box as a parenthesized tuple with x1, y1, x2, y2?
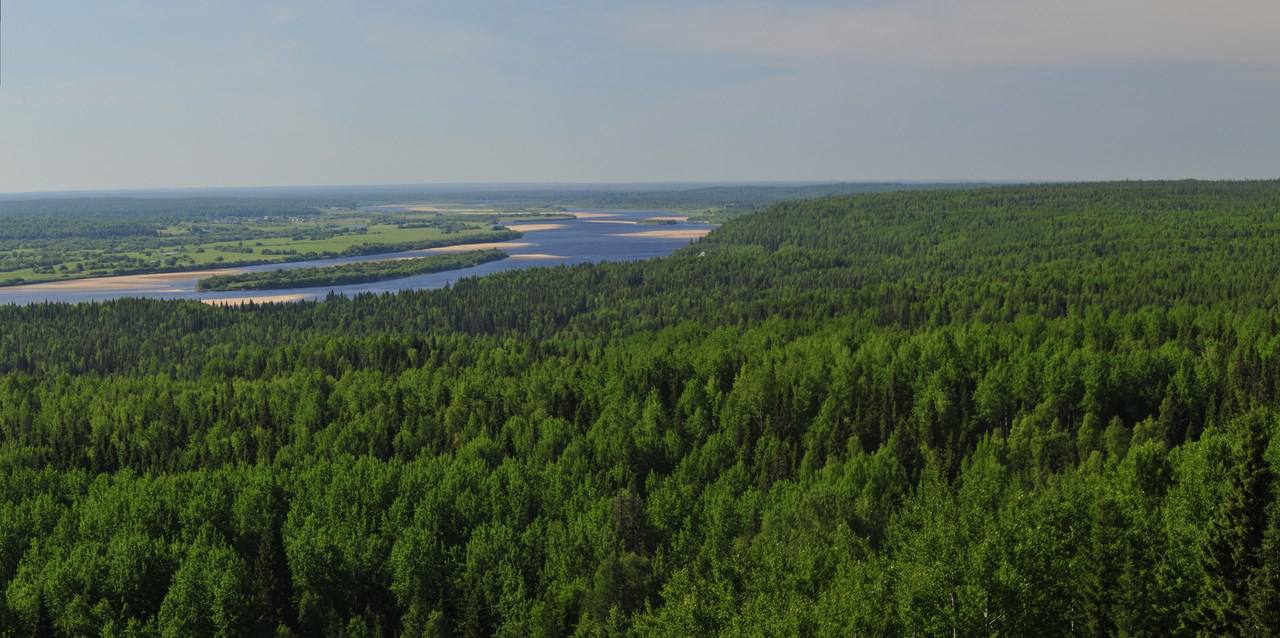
(626, 0, 1280, 65)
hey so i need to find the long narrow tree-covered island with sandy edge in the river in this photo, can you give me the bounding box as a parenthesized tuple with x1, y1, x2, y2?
(196, 249, 508, 291)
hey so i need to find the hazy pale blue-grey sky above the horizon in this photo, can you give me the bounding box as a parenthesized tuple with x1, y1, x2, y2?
(0, 0, 1280, 192)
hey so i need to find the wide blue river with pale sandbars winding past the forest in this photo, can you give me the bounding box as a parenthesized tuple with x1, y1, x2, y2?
(0, 211, 713, 304)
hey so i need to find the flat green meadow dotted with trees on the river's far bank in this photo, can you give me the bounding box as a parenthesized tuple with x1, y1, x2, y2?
(0, 208, 529, 286)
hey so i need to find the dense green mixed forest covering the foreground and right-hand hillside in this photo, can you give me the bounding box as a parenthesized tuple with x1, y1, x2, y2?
(0, 182, 1280, 637)
